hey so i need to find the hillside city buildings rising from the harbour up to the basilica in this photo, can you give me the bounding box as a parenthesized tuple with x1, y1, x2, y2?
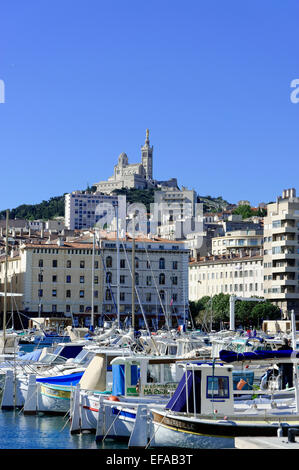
(0, 130, 299, 327)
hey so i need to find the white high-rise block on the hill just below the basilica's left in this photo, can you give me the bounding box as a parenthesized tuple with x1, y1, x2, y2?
(65, 191, 126, 230)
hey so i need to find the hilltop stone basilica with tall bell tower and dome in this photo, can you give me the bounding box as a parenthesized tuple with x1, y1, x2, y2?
(94, 129, 177, 194)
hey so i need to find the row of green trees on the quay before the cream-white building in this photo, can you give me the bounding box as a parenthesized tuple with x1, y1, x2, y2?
(189, 293, 281, 329)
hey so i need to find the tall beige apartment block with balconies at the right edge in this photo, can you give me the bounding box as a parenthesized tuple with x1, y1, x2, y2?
(264, 188, 299, 317)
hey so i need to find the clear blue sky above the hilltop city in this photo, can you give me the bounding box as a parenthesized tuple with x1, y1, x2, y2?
(0, 0, 299, 210)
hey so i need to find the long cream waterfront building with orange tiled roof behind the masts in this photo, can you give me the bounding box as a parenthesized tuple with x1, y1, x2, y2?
(0, 233, 189, 326)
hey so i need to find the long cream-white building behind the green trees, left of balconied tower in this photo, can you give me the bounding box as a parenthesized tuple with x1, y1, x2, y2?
(189, 254, 264, 301)
